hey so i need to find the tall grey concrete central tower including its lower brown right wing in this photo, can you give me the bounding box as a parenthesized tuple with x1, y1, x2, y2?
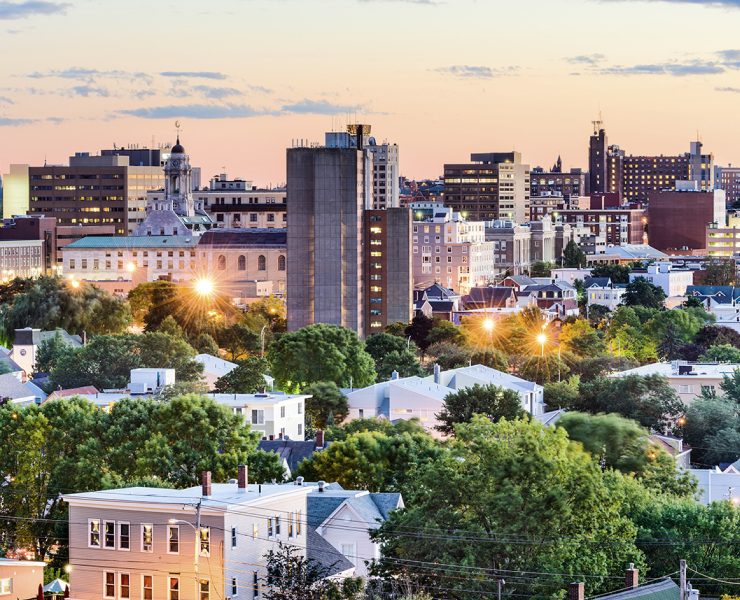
(287, 125, 412, 337)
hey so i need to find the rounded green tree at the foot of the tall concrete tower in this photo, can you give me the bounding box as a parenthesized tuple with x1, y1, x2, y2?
(269, 324, 376, 389)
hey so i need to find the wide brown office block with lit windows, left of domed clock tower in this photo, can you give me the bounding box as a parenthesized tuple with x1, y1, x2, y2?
(28, 152, 164, 235)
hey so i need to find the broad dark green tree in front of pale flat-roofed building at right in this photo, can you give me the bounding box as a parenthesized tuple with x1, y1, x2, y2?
(568, 375, 685, 432)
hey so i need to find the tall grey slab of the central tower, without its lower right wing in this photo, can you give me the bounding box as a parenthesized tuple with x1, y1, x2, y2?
(287, 147, 367, 337)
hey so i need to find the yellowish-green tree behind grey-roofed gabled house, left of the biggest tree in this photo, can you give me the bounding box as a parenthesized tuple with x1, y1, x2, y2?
(299, 426, 442, 494)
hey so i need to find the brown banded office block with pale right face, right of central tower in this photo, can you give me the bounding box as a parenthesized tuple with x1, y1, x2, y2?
(444, 152, 530, 223)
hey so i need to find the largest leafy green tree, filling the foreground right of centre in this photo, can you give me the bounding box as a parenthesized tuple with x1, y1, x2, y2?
(372, 417, 644, 598)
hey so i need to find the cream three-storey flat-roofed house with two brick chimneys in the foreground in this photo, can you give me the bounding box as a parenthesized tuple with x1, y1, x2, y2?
(64, 467, 310, 600)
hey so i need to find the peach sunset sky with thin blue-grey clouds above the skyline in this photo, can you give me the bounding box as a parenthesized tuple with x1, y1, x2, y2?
(0, 0, 740, 185)
